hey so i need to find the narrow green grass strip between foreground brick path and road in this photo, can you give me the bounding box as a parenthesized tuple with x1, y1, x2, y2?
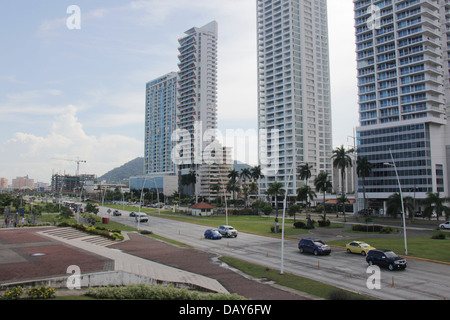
(220, 257, 368, 300)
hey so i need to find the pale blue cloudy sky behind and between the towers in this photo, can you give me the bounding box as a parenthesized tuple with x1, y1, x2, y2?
(0, 0, 358, 183)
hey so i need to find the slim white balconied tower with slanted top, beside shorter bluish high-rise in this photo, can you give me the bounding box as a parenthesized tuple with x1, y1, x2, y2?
(177, 21, 218, 168)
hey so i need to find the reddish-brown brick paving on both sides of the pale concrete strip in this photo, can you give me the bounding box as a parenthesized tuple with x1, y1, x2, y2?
(0, 228, 308, 300)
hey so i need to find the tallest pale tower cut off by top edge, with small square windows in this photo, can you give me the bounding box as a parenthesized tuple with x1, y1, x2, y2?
(257, 0, 332, 195)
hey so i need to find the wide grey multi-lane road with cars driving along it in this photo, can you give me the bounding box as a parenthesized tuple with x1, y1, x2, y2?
(99, 208, 450, 300)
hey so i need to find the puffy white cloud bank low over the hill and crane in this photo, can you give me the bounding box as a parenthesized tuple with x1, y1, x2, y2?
(0, 106, 143, 182)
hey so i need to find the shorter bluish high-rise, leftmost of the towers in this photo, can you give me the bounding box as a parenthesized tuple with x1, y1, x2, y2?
(144, 72, 178, 175)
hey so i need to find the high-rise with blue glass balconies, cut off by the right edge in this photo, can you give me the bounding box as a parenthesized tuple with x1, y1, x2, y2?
(354, 0, 450, 209)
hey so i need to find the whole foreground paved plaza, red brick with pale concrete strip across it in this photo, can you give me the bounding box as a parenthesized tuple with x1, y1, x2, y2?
(0, 228, 310, 300)
